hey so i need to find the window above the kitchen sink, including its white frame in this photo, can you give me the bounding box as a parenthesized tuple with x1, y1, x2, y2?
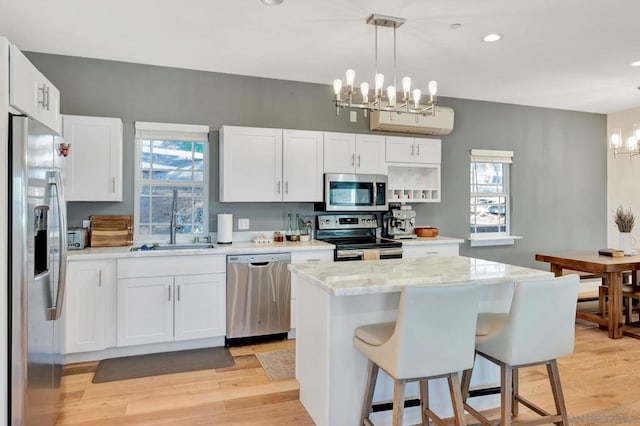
(134, 122, 209, 242)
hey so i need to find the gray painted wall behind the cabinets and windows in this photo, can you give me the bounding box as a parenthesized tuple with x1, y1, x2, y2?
(27, 53, 607, 268)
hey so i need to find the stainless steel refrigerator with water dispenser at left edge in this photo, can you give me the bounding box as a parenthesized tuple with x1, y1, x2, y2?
(8, 114, 67, 426)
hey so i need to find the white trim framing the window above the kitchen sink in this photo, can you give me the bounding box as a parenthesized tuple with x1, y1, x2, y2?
(133, 121, 211, 244)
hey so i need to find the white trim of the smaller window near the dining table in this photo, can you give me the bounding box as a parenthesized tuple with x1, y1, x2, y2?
(469, 149, 523, 247)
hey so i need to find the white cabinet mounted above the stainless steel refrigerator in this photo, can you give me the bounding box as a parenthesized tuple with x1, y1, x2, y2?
(9, 45, 60, 133)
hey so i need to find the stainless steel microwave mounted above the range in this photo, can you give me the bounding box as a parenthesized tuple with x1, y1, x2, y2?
(323, 173, 388, 211)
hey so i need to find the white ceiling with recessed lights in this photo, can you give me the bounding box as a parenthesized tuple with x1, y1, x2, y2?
(0, 0, 640, 113)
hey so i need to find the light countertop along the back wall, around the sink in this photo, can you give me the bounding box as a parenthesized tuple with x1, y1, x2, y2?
(67, 240, 334, 260)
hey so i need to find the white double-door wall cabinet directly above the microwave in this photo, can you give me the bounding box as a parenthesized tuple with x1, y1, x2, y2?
(324, 132, 387, 175)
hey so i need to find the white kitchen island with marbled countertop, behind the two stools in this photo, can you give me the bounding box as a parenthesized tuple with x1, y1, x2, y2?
(289, 256, 553, 426)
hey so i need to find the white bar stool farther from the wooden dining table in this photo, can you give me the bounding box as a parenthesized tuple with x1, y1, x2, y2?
(353, 282, 480, 426)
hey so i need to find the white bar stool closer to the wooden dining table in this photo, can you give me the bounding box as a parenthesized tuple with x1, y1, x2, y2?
(462, 275, 579, 426)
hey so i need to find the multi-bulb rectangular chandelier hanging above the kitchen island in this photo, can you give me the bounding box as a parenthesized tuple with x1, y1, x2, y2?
(333, 14, 438, 120)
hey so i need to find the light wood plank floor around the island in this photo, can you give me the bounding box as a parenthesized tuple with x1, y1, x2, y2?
(58, 323, 640, 426)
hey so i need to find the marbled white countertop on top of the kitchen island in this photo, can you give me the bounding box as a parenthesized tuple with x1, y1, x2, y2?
(289, 256, 553, 296)
